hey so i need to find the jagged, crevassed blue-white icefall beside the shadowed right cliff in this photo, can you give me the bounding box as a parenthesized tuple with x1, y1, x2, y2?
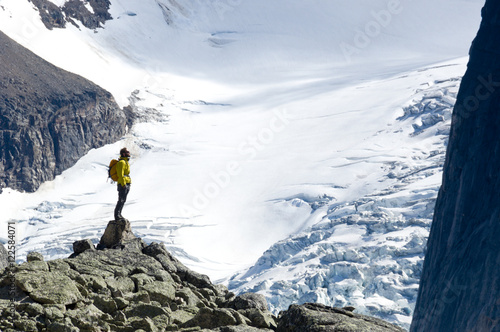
(229, 64, 463, 327)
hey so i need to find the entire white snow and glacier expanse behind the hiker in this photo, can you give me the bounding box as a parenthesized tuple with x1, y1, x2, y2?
(0, 0, 482, 325)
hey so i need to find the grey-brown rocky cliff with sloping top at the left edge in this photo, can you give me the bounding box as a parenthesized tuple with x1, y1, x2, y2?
(0, 32, 127, 191)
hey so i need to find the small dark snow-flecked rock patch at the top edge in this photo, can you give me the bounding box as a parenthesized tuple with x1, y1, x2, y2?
(29, 0, 112, 30)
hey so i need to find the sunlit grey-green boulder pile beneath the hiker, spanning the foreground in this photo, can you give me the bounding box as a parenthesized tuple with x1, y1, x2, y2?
(0, 238, 402, 332)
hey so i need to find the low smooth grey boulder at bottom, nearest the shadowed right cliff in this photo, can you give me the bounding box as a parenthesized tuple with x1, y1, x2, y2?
(276, 303, 404, 332)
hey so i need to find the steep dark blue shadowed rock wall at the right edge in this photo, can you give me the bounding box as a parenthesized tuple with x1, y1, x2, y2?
(411, 0, 500, 332)
